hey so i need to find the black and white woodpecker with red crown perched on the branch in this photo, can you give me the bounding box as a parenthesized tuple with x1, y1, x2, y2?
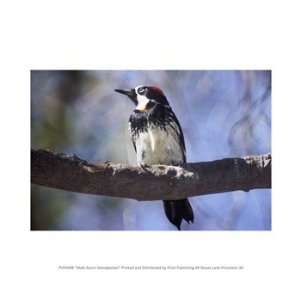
(115, 85, 194, 230)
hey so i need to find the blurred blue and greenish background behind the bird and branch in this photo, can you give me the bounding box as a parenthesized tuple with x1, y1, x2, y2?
(31, 70, 271, 230)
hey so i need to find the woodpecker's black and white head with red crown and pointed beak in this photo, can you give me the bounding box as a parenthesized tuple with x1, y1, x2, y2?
(115, 85, 169, 112)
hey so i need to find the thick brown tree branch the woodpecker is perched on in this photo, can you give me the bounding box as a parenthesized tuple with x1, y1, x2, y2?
(31, 150, 272, 200)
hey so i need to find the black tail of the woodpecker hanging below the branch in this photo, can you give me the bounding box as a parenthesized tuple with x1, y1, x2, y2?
(163, 199, 194, 230)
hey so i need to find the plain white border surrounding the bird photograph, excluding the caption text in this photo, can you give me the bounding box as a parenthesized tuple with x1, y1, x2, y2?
(0, 0, 300, 300)
